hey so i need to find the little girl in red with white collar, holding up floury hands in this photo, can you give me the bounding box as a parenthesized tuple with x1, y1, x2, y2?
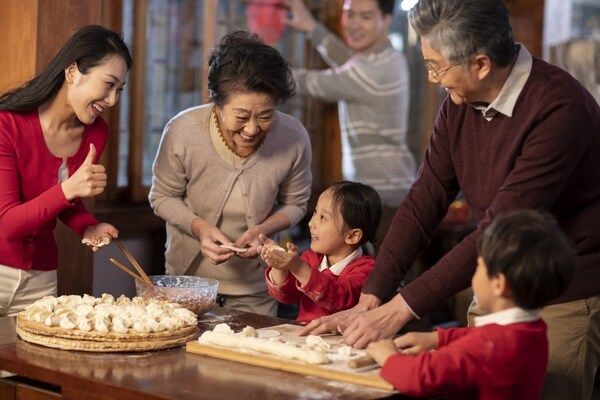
(260, 181, 381, 322)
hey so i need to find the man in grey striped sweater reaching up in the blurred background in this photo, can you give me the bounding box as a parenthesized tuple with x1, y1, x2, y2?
(287, 0, 416, 248)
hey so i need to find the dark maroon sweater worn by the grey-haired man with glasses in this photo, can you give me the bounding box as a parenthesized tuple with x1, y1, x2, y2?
(363, 58, 600, 316)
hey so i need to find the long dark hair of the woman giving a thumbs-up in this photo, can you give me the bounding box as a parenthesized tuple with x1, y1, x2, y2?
(0, 25, 132, 111)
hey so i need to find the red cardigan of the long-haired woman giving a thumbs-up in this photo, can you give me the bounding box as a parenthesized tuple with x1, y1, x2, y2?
(0, 110, 108, 271)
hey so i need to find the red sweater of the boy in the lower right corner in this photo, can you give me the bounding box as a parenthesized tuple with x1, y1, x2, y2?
(381, 319, 548, 400)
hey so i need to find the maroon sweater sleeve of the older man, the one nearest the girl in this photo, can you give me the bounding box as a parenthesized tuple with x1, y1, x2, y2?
(363, 101, 460, 304)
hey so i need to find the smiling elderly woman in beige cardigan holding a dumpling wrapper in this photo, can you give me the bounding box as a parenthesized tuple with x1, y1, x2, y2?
(149, 32, 312, 315)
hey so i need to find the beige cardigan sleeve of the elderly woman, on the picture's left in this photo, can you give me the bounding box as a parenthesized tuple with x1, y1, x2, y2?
(148, 120, 196, 235)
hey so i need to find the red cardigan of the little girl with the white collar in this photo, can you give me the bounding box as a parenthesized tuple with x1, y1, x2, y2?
(265, 250, 375, 322)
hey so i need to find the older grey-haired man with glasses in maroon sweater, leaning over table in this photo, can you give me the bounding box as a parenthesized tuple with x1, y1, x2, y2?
(305, 0, 600, 399)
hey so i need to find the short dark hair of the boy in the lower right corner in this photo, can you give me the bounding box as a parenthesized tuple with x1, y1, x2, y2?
(477, 210, 576, 309)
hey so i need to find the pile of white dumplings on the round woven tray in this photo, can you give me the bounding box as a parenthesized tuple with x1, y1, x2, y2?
(21, 293, 198, 333)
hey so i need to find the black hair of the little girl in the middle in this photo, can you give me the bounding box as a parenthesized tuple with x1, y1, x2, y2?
(327, 181, 382, 245)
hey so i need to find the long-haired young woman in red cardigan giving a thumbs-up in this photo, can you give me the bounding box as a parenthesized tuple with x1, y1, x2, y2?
(0, 25, 132, 316)
